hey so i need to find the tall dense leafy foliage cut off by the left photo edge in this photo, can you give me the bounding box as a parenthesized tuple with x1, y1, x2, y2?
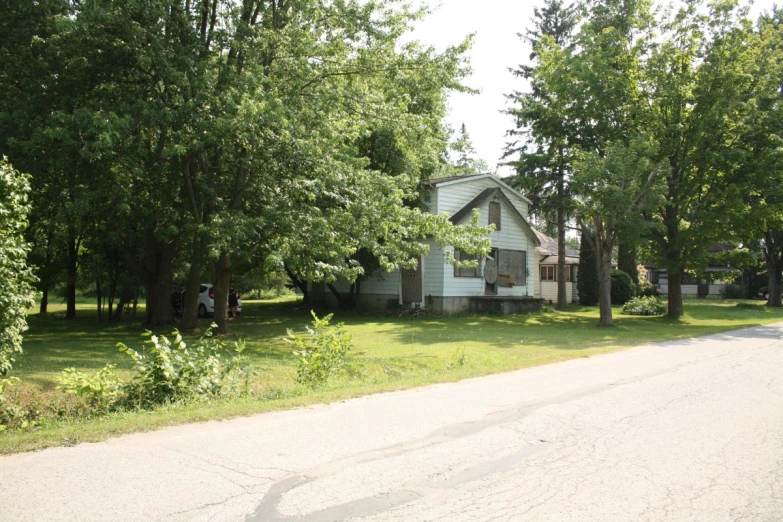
(0, 158, 34, 376)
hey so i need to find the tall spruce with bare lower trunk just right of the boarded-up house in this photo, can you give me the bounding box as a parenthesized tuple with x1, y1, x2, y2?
(505, 0, 577, 309)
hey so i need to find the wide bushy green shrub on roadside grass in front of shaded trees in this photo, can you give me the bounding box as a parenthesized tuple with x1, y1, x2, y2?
(117, 324, 245, 408)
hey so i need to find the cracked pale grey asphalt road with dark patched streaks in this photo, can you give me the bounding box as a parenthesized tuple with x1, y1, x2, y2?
(0, 324, 783, 522)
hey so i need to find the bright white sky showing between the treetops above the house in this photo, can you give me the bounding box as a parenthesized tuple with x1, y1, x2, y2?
(413, 0, 783, 175)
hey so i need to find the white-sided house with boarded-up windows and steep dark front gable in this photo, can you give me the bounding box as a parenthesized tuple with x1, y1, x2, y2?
(309, 174, 542, 313)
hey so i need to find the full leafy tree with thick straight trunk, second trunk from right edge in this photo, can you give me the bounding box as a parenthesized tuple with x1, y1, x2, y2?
(644, 0, 761, 318)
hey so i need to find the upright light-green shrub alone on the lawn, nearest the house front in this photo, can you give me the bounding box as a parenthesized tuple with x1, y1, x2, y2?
(286, 311, 351, 386)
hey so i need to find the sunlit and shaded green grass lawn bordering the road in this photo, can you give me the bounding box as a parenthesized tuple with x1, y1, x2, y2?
(0, 298, 783, 454)
